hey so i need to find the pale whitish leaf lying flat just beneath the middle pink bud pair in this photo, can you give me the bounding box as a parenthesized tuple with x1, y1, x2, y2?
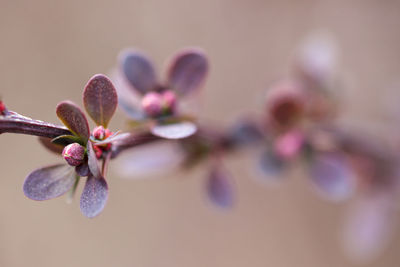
(151, 121, 197, 139)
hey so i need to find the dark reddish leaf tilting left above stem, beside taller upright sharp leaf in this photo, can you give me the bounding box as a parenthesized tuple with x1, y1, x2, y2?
(56, 101, 90, 143)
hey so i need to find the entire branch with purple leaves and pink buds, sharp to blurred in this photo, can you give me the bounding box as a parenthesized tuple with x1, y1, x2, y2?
(0, 39, 400, 262)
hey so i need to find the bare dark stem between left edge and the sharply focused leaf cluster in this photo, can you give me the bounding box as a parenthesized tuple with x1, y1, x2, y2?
(0, 111, 71, 138)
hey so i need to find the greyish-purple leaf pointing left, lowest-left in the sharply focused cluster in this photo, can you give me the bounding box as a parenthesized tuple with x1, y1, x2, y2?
(23, 164, 75, 200)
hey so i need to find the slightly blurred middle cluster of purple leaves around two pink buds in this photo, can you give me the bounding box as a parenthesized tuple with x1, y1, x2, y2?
(117, 48, 208, 139)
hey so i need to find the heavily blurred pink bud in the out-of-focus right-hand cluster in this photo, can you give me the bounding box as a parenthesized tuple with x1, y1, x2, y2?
(275, 130, 304, 159)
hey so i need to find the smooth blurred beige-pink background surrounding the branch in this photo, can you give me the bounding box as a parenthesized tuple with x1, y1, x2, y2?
(0, 0, 400, 267)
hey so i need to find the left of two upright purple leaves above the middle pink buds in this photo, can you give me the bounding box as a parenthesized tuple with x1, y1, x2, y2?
(120, 51, 157, 94)
